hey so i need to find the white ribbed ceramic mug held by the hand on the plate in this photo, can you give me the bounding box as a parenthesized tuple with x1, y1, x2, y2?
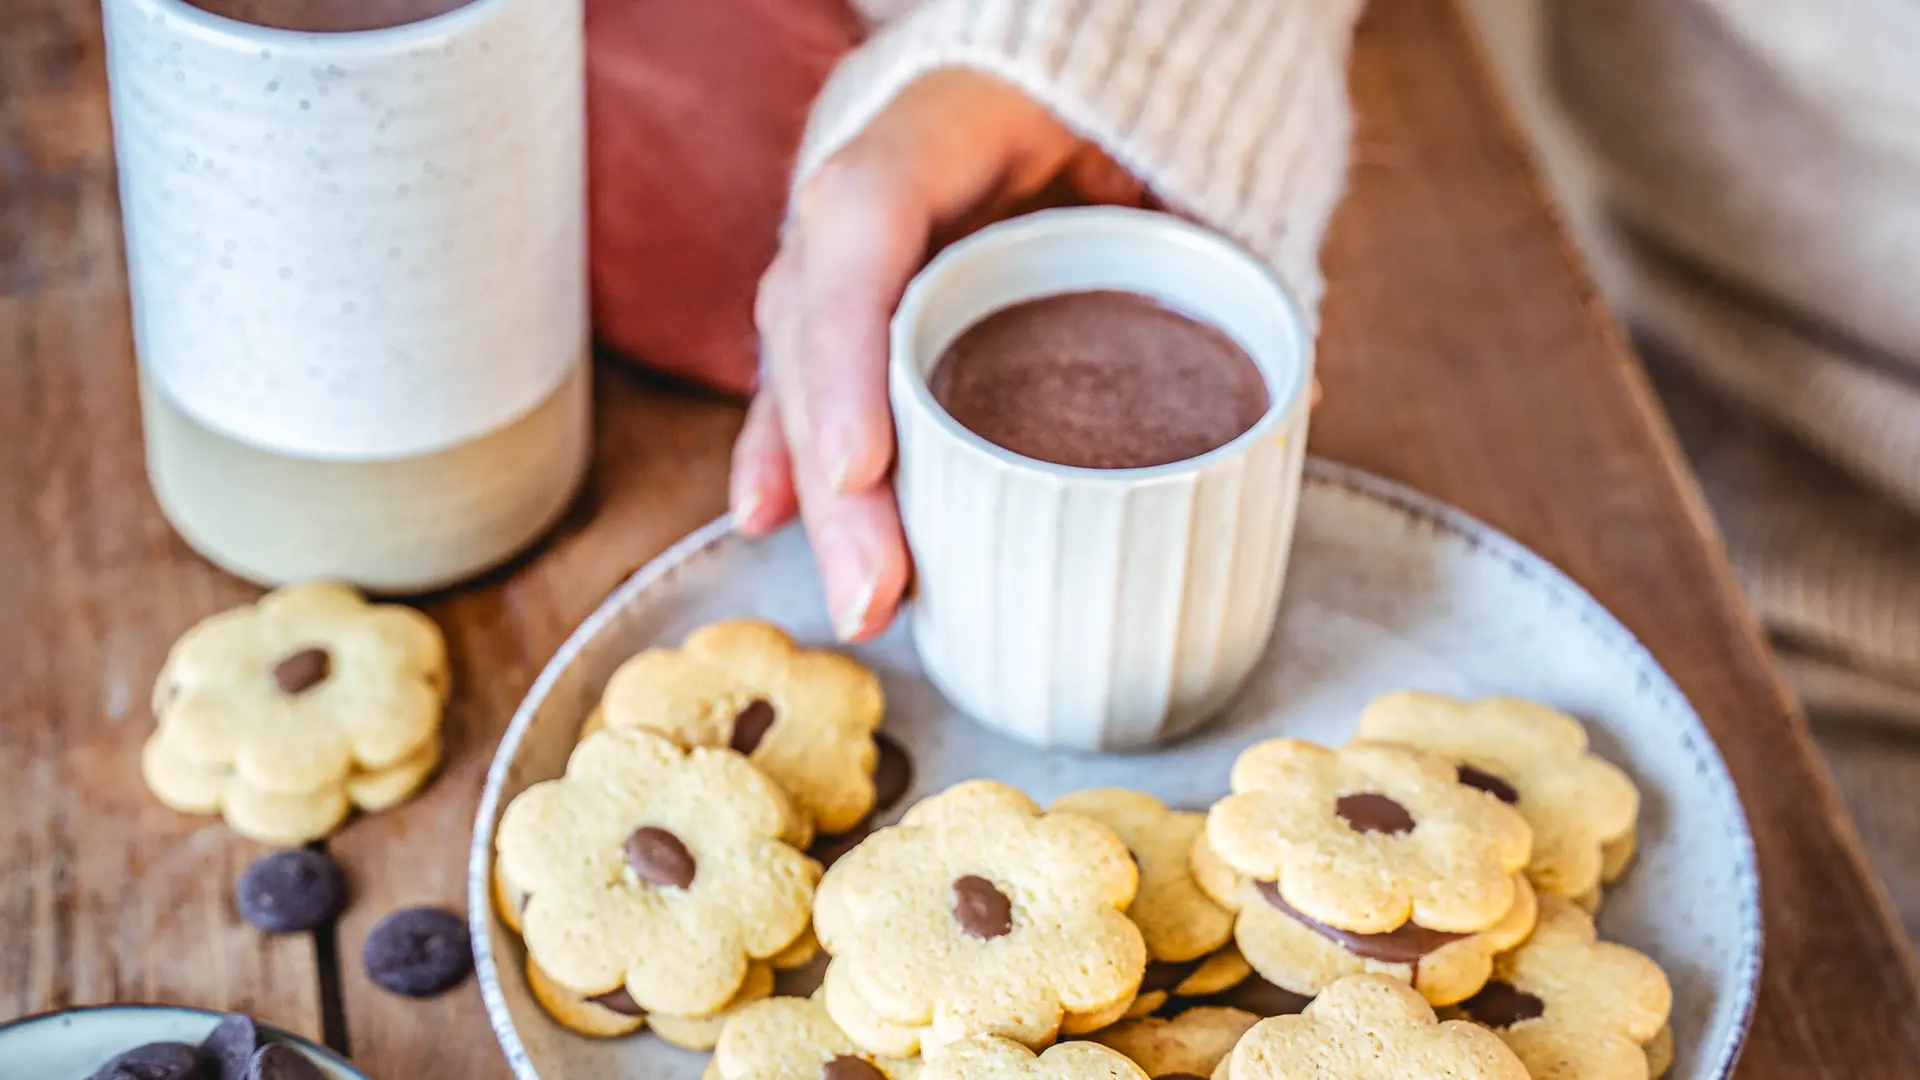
(891, 208, 1313, 749)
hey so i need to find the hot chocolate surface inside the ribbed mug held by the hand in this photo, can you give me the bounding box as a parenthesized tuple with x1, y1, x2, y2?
(927, 290, 1269, 469)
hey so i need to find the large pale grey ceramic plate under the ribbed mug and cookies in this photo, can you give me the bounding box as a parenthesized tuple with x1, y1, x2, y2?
(468, 461, 1761, 1080)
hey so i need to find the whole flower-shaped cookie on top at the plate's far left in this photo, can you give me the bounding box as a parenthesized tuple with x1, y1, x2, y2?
(495, 728, 820, 1017)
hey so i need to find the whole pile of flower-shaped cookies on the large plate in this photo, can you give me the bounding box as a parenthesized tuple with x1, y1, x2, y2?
(495, 623, 1670, 1080)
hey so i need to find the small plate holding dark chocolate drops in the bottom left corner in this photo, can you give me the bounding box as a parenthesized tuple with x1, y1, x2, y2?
(0, 1005, 367, 1080)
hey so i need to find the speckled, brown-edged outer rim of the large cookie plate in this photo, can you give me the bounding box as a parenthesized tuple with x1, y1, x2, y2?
(467, 457, 1764, 1080)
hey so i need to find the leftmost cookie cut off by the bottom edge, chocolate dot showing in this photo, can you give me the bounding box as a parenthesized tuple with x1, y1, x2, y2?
(707, 997, 920, 1080)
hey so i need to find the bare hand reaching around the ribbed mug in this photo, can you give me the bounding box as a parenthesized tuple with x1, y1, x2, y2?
(732, 69, 1144, 640)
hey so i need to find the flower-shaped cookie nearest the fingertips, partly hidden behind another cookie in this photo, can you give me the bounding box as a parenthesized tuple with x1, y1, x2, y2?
(601, 619, 885, 836)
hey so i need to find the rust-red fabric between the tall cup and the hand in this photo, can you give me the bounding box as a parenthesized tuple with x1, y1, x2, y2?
(586, 0, 860, 394)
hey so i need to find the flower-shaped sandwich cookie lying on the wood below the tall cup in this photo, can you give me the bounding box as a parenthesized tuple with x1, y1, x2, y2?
(142, 584, 449, 844)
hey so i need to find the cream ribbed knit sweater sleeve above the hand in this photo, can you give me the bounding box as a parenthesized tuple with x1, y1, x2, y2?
(797, 0, 1361, 311)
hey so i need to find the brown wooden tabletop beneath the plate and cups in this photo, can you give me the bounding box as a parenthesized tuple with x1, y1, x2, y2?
(11, 0, 1920, 1080)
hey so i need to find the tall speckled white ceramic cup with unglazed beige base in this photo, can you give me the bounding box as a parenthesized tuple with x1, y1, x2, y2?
(104, 0, 591, 592)
